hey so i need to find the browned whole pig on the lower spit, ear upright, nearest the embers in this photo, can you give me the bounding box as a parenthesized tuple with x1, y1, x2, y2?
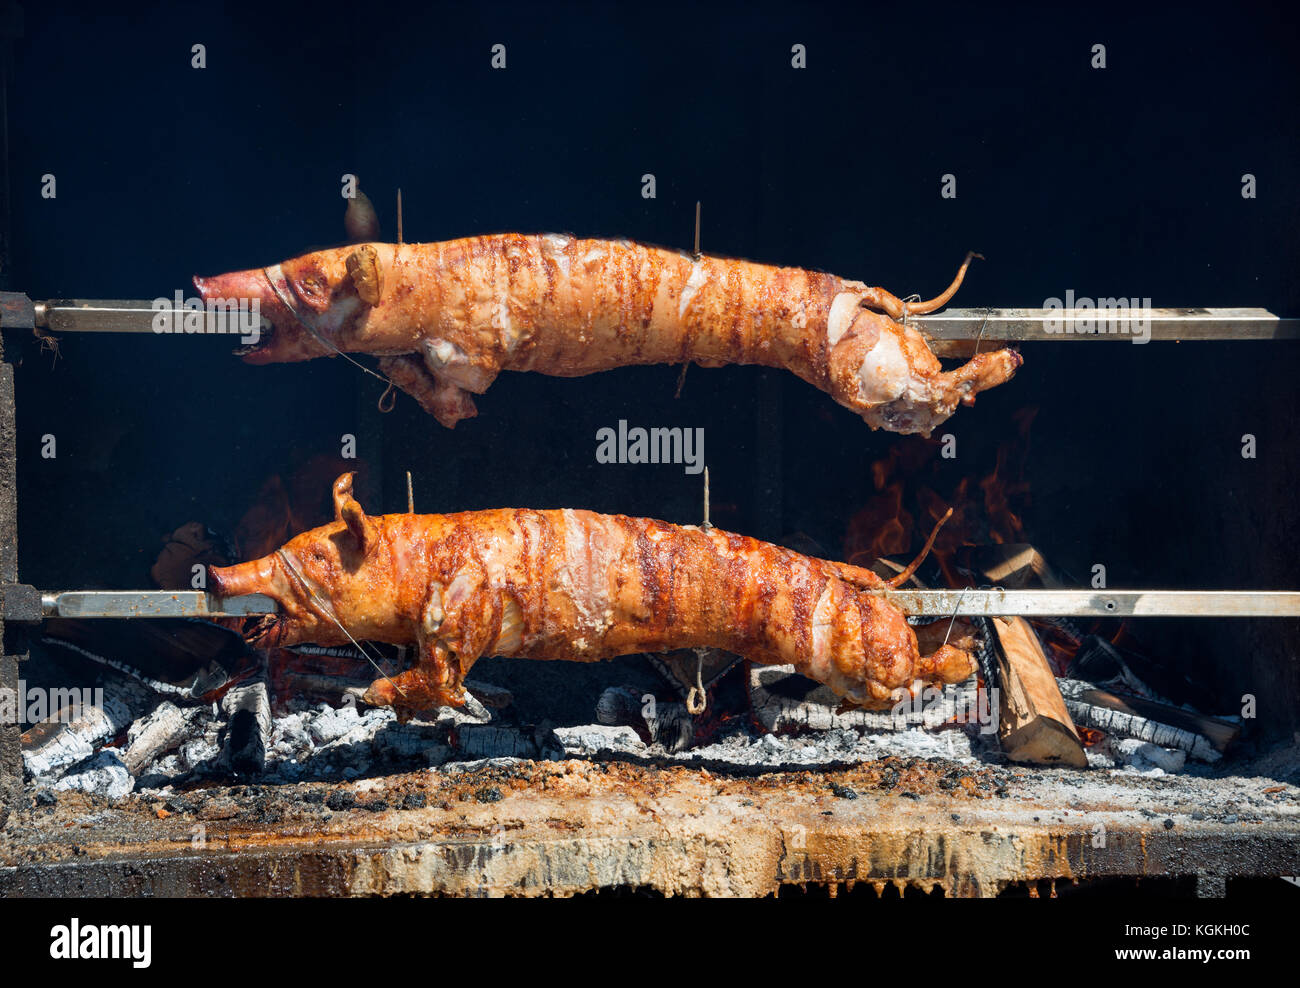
(211, 475, 974, 712)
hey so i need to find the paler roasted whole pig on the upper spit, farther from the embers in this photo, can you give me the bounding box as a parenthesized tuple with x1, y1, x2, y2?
(195, 234, 1021, 434)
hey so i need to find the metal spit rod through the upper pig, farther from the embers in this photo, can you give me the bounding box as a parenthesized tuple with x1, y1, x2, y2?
(0, 293, 1300, 343)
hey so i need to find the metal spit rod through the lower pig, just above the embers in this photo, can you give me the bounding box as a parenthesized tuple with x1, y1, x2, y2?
(30, 590, 1300, 618)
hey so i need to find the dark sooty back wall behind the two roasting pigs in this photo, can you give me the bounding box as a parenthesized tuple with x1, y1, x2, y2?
(9, 3, 1300, 733)
